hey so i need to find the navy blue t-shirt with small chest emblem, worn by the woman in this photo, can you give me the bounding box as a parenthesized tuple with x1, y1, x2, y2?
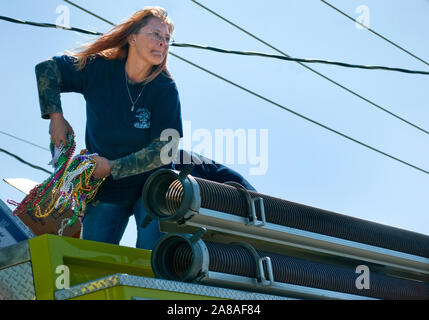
(53, 55, 183, 203)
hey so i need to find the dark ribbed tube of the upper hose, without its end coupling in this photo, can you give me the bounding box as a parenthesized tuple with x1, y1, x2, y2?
(195, 178, 429, 257)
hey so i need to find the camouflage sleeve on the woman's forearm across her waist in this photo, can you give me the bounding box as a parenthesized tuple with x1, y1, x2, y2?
(109, 137, 180, 180)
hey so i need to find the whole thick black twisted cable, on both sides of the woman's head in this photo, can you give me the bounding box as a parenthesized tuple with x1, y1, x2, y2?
(0, 16, 429, 75)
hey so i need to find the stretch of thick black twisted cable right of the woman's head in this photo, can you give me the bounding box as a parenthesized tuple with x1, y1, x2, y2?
(170, 43, 429, 75)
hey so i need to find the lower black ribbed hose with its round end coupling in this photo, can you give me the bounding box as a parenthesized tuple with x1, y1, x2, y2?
(152, 234, 429, 299)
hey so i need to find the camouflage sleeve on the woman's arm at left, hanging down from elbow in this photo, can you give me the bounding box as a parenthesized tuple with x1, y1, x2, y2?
(36, 59, 62, 119)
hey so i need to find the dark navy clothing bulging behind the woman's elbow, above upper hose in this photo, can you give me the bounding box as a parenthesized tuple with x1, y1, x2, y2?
(173, 150, 256, 191)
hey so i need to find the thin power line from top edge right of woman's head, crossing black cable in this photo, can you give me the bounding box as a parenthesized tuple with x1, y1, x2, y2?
(191, 0, 429, 134)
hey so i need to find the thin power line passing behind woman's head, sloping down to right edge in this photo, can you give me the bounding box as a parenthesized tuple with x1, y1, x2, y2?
(5, 0, 429, 174)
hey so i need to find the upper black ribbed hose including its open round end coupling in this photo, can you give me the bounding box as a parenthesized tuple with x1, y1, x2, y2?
(143, 170, 429, 258)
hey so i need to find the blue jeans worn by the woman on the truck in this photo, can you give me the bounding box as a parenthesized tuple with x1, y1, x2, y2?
(82, 197, 162, 250)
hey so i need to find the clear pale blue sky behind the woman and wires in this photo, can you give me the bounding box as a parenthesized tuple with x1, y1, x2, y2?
(0, 0, 429, 246)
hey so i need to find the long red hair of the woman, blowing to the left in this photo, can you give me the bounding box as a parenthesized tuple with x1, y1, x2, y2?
(71, 7, 174, 82)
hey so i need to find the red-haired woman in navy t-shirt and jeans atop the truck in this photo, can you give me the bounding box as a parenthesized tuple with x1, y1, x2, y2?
(36, 7, 182, 249)
